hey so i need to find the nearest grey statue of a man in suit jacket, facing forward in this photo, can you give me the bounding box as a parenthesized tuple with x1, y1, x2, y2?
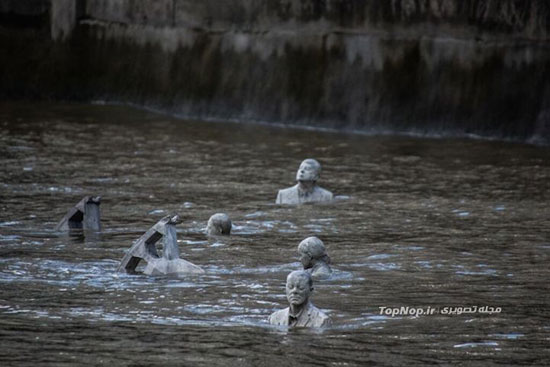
(269, 270, 332, 328)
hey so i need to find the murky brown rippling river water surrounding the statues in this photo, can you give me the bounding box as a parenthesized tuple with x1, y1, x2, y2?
(0, 103, 550, 366)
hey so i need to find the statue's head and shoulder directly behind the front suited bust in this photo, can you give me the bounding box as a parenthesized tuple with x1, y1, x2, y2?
(298, 237, 332, 280)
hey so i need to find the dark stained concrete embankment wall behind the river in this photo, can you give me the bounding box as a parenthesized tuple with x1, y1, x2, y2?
(0, 0, 550, 141)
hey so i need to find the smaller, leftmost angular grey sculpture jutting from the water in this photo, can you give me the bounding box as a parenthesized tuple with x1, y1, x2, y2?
(55, 196, 101, 231)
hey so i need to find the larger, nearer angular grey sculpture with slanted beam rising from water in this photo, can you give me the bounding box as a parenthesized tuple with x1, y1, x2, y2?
(117, 215, 204, 275)
